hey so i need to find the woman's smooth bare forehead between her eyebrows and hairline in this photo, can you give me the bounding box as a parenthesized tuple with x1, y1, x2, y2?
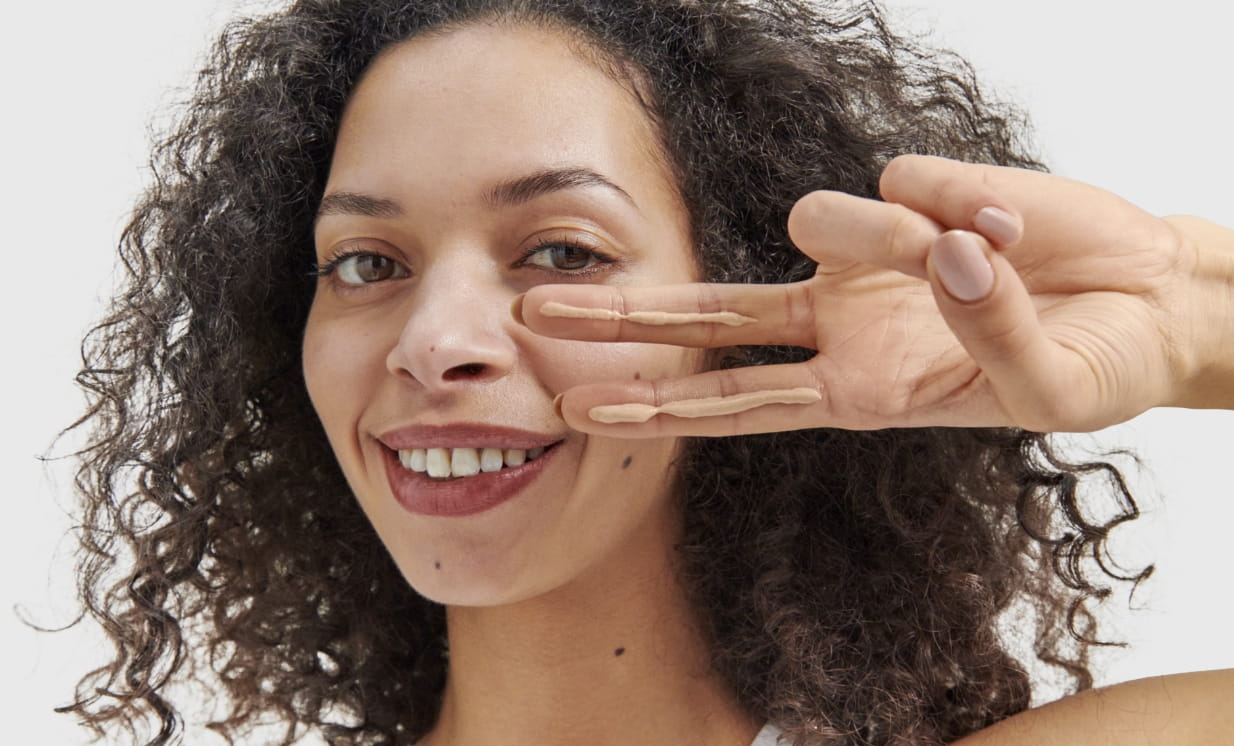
(332, 23, 676, 202)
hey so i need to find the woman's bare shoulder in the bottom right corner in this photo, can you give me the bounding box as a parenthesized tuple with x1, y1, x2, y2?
(953, 670, 1234, 746)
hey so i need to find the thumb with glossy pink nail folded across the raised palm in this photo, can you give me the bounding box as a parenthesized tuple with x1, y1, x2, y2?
(927, 231, 1092, 432)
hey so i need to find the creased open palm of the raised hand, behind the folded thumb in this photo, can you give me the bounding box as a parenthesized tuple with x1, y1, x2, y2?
(808, 233, 1166, 429)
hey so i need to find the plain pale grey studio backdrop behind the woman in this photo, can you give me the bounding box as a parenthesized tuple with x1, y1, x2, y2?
(0, 0, 1234, 745)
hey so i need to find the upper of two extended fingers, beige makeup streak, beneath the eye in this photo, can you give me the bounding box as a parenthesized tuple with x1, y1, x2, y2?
(512, 282, 817, 348)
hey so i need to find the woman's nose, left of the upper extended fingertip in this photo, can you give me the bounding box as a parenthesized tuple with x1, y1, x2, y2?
(386, 268, 517, 391)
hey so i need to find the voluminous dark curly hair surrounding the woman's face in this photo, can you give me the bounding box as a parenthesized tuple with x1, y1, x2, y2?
(62, 0, 1148, 745)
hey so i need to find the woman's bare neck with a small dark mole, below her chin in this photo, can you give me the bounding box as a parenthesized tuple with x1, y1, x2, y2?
(426, 508, 761, 746)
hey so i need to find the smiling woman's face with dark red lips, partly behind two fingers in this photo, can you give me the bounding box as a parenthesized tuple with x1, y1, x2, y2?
(304, 25, 701, 605)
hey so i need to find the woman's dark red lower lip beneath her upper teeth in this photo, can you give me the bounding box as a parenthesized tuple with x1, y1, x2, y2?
(380, 446, 557, 518)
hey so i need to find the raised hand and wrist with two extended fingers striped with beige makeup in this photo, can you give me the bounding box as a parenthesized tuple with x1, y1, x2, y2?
(521, 157, 1234, 438)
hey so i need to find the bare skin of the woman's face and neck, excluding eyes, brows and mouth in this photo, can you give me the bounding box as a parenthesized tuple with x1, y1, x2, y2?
(304, 25, 756, 746)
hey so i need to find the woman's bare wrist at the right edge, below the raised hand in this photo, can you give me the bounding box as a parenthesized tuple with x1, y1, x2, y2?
(1165, 216, 1234, 409)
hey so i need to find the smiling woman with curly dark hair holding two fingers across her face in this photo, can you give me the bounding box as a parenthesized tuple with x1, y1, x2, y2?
(60, 2, 1232, 745)
